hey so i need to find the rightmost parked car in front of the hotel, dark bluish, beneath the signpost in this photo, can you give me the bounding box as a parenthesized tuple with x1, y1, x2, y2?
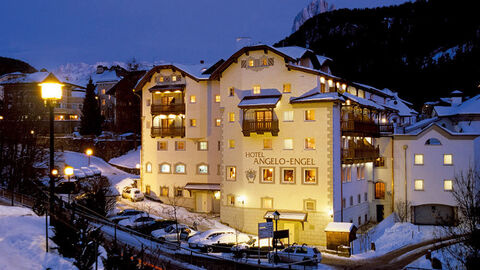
(267, 244, 322, 264)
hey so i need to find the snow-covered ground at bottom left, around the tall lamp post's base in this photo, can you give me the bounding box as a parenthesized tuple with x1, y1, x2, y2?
(0, 205, 77, 270)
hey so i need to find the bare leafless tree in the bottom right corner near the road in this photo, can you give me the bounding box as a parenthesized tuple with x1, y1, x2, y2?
(442, 168, 480, 269)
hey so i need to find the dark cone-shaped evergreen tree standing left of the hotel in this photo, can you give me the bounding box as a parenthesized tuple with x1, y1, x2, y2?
(80, 79, 103, 136)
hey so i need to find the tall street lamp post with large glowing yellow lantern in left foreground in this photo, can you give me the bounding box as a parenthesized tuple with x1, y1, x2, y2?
(39, 73, 63, 248)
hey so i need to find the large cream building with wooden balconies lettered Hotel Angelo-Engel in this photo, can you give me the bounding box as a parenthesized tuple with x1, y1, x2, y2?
(136, 45, 422, 245)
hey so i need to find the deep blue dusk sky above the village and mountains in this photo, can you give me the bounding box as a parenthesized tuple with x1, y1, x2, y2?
(0, 0, 406, 69)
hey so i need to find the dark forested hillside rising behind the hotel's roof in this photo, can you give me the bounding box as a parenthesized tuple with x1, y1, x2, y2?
(275, 0, 480, 105)
